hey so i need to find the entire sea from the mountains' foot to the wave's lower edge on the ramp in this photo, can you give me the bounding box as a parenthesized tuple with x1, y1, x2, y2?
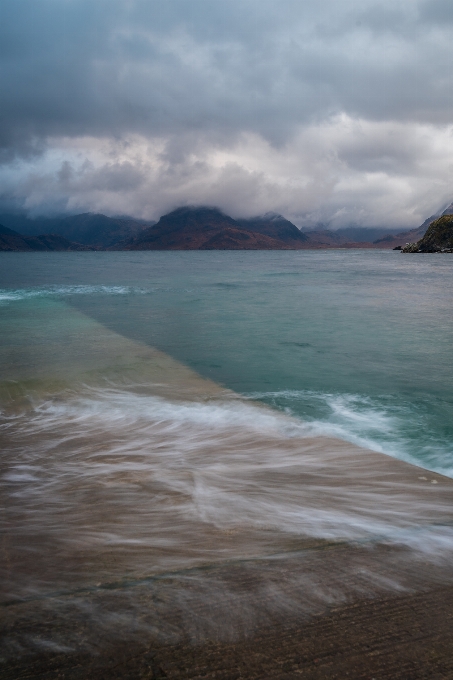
(0, 249, 453, 653)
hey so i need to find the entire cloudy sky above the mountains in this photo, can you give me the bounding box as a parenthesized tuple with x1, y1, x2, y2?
(0, 0, 453, 228)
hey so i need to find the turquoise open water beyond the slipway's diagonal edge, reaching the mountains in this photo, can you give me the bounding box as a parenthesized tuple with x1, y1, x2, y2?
(0, 250, 453, 476)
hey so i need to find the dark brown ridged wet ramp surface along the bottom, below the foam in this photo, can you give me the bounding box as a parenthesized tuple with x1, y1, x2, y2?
(2, 545, 453, 680)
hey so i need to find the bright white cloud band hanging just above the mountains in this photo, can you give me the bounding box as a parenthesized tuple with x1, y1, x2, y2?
(2, 115, 453, 227)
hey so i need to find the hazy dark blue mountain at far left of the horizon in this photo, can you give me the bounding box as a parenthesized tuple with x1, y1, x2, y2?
(0, 213, 154, 248)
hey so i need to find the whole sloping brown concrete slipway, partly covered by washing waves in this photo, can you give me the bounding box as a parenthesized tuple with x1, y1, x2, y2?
(0, 302, 453, 680)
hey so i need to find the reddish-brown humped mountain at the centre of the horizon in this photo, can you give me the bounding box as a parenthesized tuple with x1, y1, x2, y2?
(120, 206, 306, 250)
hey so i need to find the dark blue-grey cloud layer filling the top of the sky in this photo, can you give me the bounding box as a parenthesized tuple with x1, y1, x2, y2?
(1, 0, 453, 146)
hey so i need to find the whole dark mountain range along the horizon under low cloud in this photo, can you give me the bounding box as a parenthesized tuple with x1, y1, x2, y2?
(0, 203, 453, 251)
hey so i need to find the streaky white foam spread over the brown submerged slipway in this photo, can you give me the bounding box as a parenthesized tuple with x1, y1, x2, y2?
(5, 389, 453, 560)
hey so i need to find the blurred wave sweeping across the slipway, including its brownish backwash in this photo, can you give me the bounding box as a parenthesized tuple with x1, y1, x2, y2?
(1, 388, 453, 596)
